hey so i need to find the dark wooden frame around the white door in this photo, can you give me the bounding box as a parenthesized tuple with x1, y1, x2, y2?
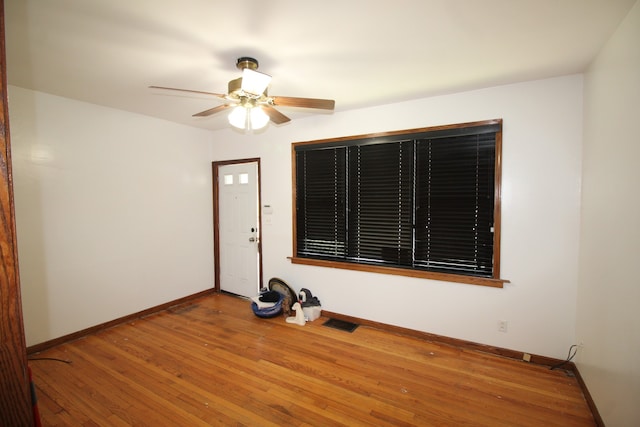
(211, 157, 263, 292)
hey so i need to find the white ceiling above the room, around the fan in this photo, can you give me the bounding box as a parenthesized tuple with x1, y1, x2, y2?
(5, 0, 636, 129)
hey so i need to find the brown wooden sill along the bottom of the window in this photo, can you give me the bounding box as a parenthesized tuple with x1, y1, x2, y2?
(288, 257, 509, 288)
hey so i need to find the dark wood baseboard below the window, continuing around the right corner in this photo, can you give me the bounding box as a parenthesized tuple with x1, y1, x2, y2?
(322, 310, 605, 427)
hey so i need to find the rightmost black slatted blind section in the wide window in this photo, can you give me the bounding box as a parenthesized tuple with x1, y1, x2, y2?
(415, 133, 495, 277)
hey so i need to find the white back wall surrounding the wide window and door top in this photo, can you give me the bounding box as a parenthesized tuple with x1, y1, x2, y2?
(213, 75, 582, 358)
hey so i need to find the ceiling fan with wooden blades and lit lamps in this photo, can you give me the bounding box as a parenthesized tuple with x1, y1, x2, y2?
(149, 56, 335, 130)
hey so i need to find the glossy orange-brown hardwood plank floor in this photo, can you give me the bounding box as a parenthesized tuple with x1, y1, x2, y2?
(29, 294, 595, 427)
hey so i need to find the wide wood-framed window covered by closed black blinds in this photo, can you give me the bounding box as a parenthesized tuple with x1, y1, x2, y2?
(292, 120, 505, 287)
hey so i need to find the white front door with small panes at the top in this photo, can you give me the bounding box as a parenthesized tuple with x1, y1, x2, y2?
(218, 162, 260, 297)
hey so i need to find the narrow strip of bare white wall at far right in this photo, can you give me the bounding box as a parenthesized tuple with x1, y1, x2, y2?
(577, 3, 640, 426)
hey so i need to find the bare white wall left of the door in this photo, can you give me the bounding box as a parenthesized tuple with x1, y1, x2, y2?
(9, 86, 213, 345)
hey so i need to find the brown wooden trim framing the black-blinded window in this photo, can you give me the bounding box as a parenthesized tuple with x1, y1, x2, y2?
(289, 119, 509, 288)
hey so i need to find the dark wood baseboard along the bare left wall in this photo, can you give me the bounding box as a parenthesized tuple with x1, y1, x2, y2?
(27, 289, 215, 356)
